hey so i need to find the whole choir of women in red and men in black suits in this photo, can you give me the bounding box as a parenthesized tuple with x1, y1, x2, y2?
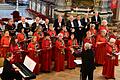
(0, 12, 120, 78)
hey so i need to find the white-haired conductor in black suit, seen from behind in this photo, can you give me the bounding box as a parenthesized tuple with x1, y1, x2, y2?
(81, 43, 95, 80)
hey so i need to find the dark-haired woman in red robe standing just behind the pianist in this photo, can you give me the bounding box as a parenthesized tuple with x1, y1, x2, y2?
(10, 37, 24, 63)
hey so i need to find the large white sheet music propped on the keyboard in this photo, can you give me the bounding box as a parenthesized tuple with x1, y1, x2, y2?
(23, 56, 36, 72)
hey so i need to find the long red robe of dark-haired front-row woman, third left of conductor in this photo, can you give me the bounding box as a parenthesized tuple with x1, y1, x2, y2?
(41, 39, 52, 72)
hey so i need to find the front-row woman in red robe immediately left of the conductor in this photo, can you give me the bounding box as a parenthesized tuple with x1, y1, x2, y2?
(66, 34, 78, 69)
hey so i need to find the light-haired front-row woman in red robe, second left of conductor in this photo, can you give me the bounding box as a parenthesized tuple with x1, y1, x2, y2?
(55, 33, 65, 72)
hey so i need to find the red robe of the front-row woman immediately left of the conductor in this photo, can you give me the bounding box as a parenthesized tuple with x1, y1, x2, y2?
(66, 39, 78, 69)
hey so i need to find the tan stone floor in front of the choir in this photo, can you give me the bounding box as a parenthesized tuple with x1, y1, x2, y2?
(35, 61, 120, 80)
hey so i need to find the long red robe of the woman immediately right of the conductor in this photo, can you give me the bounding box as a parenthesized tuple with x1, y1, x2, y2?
(95, 34, 107, 65)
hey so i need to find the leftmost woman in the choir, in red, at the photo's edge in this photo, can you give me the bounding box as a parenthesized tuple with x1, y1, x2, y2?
(1, 30, 11, 58)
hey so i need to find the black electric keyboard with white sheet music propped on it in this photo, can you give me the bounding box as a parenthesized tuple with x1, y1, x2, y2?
(13, 56, 36, 79)
